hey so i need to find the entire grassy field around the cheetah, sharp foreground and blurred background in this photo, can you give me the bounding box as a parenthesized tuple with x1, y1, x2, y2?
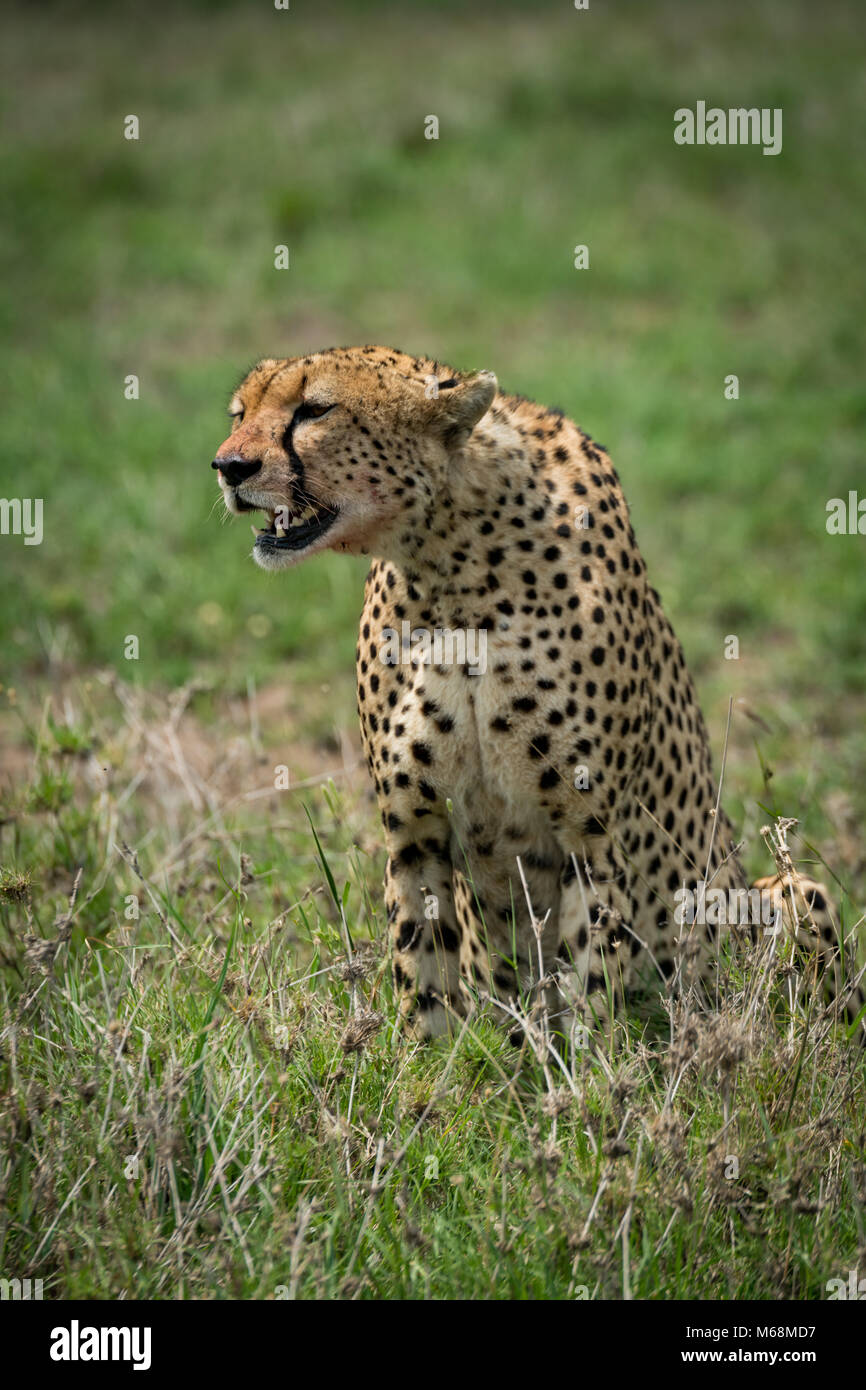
(0, 0, 866, 1298)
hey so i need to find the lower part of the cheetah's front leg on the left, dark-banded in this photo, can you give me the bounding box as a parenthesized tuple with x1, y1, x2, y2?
(385, 819, 463, 1038)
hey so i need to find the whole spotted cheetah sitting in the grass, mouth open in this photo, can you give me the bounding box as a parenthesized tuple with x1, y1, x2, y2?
(213, 346, 862, 1038)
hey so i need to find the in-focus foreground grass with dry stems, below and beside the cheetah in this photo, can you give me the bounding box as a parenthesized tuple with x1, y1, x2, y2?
(0, 692, 866, 1300)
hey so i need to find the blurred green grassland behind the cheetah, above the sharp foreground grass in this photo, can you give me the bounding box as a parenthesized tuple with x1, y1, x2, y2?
(0, 0, 866, 870)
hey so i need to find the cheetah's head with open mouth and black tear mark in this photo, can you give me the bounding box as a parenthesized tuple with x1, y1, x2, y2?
(213, 348, 496, 570)
